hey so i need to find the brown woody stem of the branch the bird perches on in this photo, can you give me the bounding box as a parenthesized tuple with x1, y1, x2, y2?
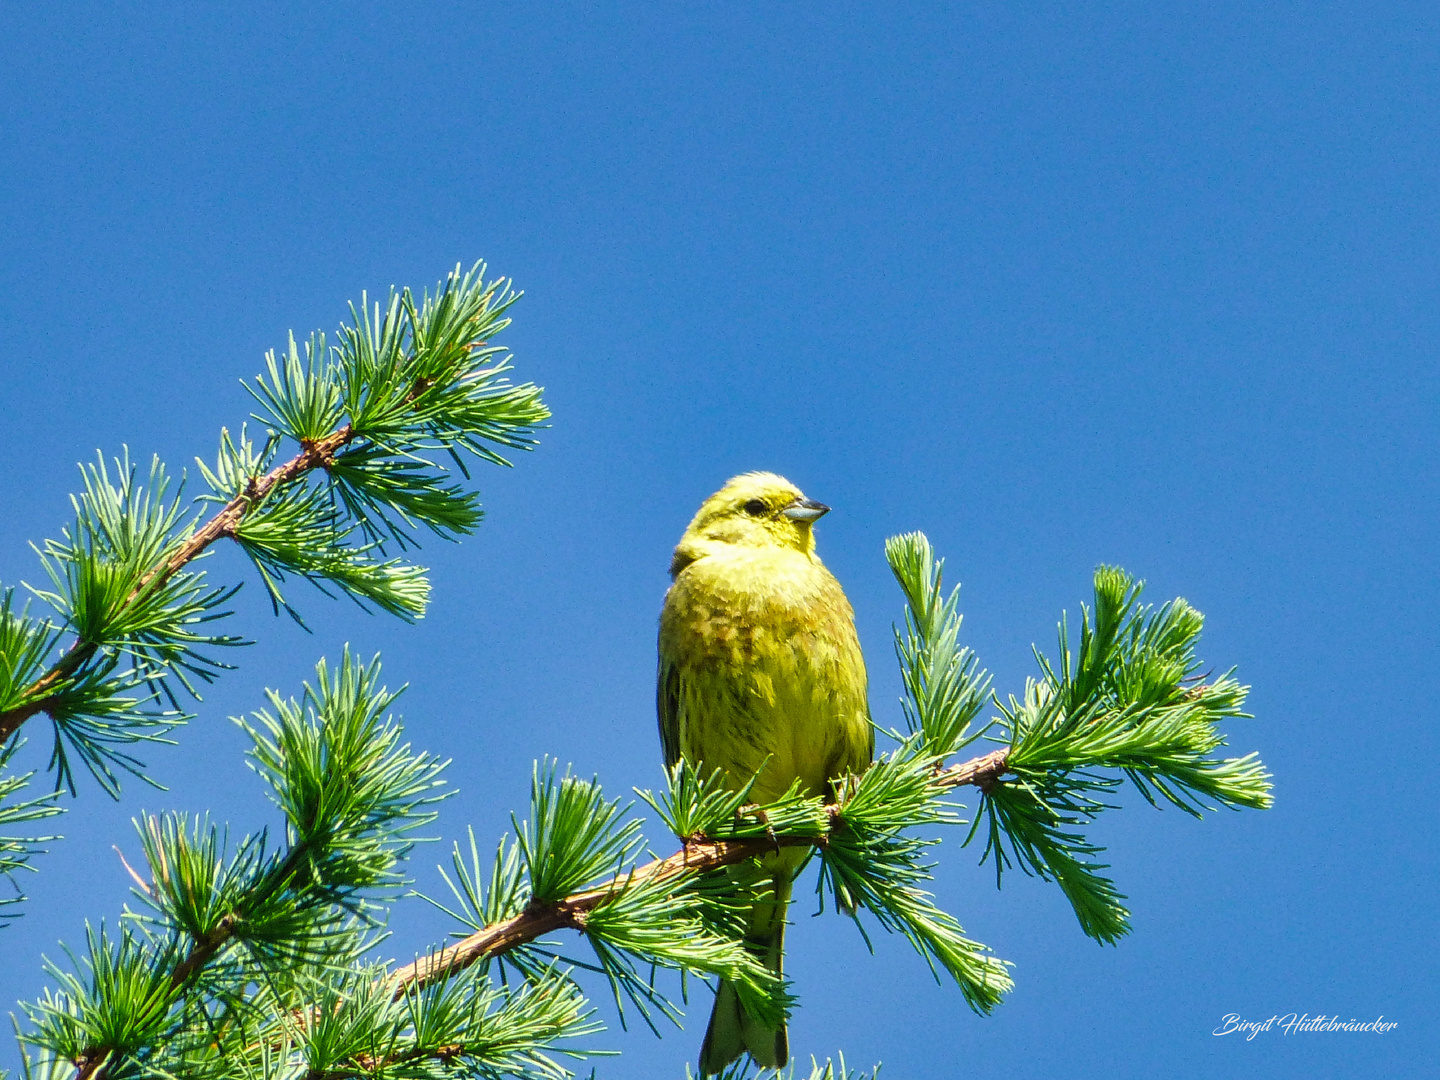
(389, 746, 1009, 996)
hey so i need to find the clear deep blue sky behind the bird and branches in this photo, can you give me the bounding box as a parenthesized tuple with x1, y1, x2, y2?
(0, 3, 1440, 1080)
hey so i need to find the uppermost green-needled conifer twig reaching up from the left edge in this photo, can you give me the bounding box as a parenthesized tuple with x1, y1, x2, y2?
(0, 264, 550, 795)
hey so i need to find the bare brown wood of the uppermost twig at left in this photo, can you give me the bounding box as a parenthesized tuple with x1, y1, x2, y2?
(0, 423, 354, 746)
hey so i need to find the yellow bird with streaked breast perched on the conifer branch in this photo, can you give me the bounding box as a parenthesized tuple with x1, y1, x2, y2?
(655, 472, 874, 1074)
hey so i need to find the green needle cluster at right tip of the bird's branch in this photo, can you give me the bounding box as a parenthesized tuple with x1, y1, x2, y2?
(971, 566, 1272, 945)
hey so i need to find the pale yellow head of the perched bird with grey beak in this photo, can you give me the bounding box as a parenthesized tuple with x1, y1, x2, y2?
(670, 472, 829, 577)
